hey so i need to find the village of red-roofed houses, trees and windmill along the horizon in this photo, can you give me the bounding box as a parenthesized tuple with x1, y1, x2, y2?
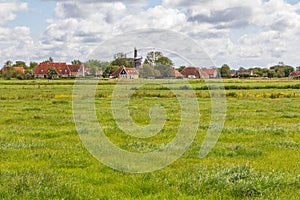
(0, 48, 300, 79)
